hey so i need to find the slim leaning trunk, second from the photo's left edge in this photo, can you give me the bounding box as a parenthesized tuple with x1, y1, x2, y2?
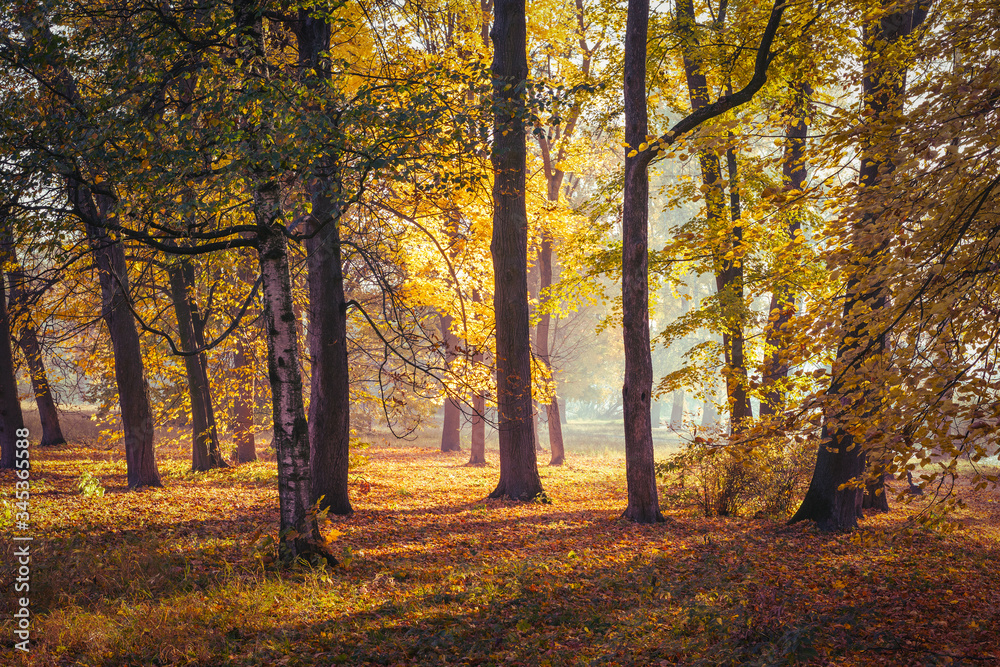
(8, 269, 66, 447)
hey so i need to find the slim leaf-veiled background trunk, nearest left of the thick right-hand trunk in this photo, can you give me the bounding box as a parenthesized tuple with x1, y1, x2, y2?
(760, 82, 812, 417)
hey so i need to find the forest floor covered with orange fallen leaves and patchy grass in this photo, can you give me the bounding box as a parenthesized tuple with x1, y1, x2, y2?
(0, 422, 1000, 667)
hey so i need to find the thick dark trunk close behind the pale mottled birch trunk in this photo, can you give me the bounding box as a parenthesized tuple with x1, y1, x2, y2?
(296, 9, 353, 515)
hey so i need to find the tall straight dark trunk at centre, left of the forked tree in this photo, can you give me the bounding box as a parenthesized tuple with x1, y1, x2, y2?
(490, 0, 544, 500)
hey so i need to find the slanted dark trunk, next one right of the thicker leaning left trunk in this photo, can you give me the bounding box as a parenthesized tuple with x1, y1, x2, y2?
(167, 260, 228, 471)
